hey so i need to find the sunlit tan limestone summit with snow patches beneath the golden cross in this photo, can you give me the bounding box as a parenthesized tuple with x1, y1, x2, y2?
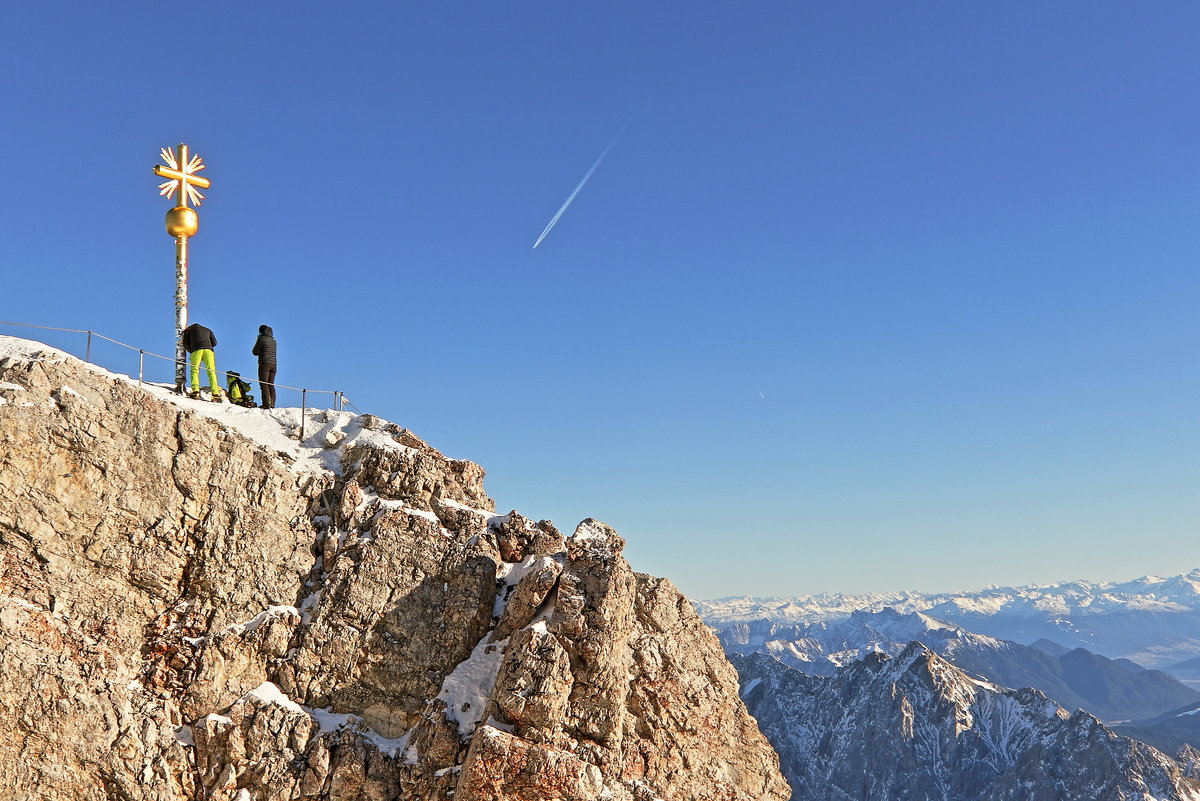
(0, 338, 790, 801)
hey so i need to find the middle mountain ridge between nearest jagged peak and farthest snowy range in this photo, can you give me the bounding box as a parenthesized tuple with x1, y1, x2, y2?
(716, 608, 1200, 724)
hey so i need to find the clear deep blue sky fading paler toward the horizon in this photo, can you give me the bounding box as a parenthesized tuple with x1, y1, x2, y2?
(0, 1, 1200, 597)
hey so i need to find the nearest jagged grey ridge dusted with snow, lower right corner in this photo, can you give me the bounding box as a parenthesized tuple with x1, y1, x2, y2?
(733, 643, 1200, 801)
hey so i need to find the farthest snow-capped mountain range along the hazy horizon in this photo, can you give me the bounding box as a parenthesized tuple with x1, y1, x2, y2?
(696, 568, 1200, 671)
